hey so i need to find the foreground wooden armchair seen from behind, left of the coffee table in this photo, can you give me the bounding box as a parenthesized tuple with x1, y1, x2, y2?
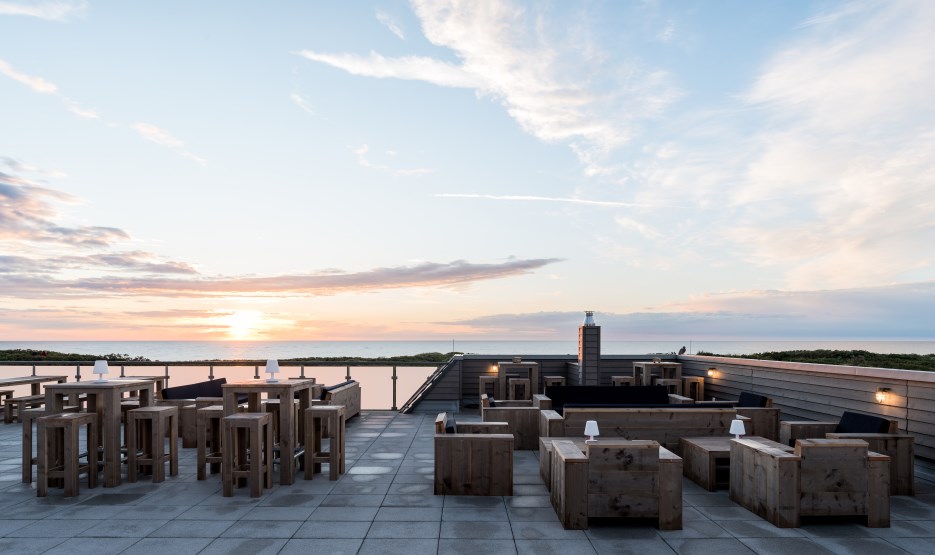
(551, 439, 682, 530)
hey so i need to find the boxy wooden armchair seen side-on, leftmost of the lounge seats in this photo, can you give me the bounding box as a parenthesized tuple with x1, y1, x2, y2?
(435, 412, 513, 495)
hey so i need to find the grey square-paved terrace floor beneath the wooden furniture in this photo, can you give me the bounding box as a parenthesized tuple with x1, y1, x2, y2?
(0, 411, 935, 555)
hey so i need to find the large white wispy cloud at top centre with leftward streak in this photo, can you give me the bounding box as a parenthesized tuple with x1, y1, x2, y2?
(299, 0, 679, 175)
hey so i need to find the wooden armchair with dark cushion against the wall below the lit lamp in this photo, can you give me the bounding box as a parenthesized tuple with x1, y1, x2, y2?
(779, 411, 915, 495)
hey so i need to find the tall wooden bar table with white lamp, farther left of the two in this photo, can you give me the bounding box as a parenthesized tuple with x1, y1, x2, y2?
(45, 378, 153, 488)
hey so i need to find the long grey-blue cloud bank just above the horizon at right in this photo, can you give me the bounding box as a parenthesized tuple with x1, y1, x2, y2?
(435, 281, 935, 340)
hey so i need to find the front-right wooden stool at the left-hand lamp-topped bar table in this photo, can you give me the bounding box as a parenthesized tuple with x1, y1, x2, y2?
(127, 406, 179, 484)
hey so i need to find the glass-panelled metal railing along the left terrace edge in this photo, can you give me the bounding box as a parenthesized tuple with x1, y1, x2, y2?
(0, 360, 447, 410)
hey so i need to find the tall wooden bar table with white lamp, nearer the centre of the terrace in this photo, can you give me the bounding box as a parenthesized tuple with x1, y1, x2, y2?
(221, 378, 319, 486)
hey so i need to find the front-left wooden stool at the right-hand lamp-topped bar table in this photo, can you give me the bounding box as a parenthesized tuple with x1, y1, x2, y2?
(221, 412, 273, 497)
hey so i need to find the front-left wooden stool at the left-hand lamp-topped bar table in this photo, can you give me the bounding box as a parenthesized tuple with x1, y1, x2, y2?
(35, 412, 100, 497)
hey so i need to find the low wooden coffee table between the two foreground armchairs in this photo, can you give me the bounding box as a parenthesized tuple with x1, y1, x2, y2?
(679, 436, 793, 491)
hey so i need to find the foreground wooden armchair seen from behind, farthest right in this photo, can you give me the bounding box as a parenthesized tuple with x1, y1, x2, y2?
(730, 439, 890, 528)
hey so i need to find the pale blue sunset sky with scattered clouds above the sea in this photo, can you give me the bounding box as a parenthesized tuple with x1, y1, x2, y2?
(0, 0, 935, 341)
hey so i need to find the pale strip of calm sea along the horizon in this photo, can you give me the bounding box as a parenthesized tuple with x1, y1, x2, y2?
(0, 340, 935, 362)
